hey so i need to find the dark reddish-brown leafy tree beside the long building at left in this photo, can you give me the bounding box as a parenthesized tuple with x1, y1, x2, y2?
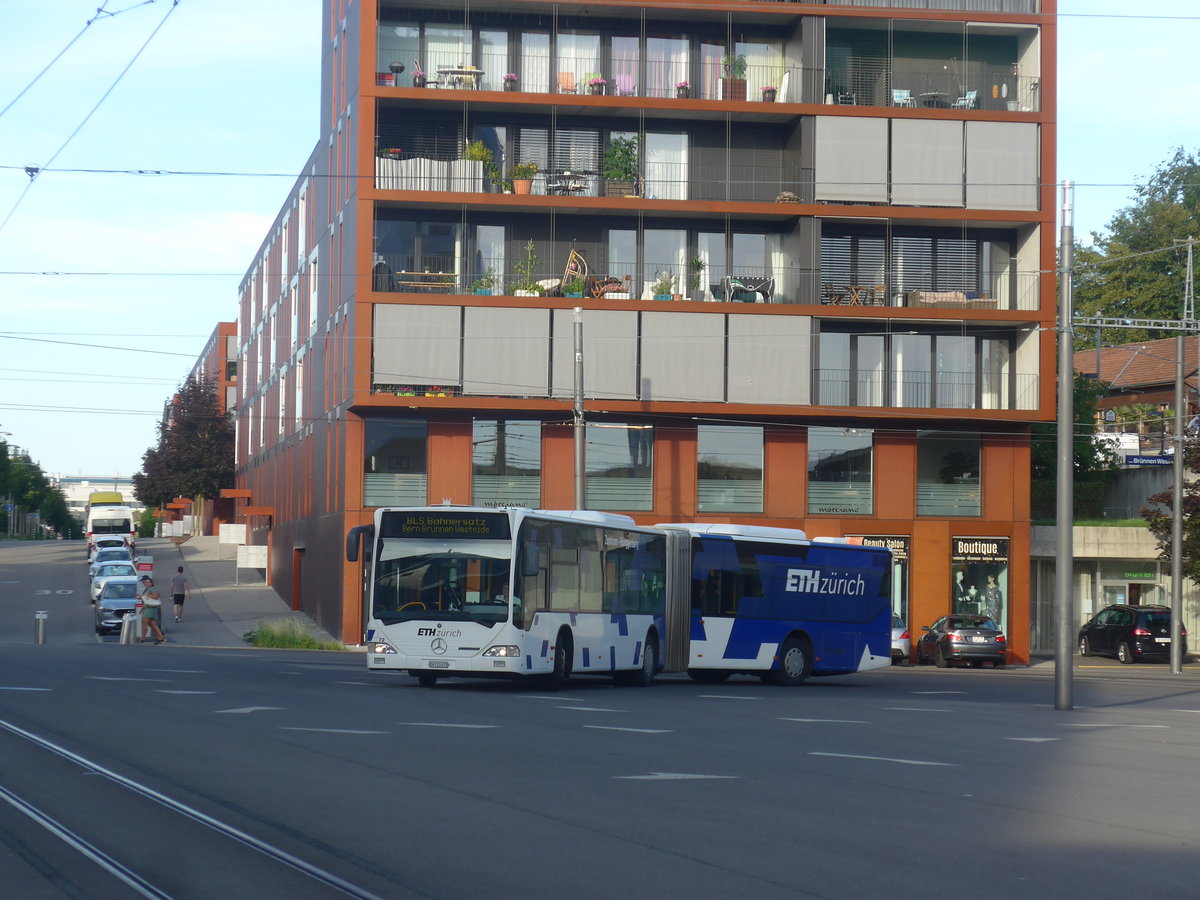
(133, 377, 234, 506)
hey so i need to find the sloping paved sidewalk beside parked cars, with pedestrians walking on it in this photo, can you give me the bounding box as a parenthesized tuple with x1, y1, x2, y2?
(138, 536, 336, 647)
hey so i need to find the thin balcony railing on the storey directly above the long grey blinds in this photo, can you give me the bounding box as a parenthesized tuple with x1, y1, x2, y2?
(372, 252, 1040, 316)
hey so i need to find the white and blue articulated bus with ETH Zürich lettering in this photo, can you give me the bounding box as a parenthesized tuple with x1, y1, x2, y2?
(346, 506, 892, 688)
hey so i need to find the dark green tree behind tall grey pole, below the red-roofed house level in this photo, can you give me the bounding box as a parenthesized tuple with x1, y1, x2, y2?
(1030, 373, 1120, 518)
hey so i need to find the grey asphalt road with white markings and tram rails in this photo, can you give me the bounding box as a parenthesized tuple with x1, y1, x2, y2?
(0, 544, 1200, 899)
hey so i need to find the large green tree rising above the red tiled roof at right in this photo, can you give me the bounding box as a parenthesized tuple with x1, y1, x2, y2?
(1074, 146, 1200, 348)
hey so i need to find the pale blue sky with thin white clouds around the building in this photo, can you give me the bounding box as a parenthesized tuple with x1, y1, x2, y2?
(0, 0, 1200, 487)
